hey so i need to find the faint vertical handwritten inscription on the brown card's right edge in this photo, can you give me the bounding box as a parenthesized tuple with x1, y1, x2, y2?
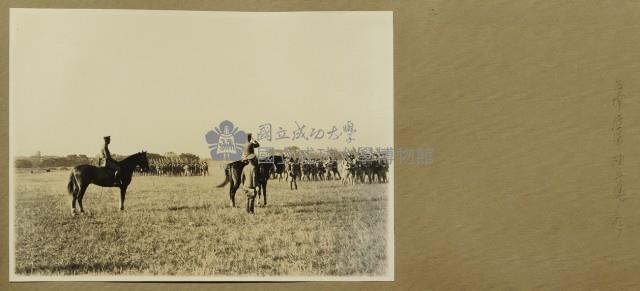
(611, 80, 626, 238)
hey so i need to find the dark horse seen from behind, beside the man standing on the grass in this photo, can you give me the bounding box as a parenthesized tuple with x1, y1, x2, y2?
(216, 156, 275, 213)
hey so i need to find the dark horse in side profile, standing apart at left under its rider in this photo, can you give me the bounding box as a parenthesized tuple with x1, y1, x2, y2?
(67, 151, 149, 214)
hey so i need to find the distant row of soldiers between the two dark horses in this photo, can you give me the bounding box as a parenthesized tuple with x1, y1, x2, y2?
(141, 158, 209, 176)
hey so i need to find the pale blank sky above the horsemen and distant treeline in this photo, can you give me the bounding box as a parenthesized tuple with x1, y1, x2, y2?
(10, 9, 393, 157)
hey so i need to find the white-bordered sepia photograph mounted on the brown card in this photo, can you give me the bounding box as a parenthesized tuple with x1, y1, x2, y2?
(8, 8, 392, 282)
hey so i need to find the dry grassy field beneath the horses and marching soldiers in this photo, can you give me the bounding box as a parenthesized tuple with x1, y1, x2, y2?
(14, 167, 389, 276)
